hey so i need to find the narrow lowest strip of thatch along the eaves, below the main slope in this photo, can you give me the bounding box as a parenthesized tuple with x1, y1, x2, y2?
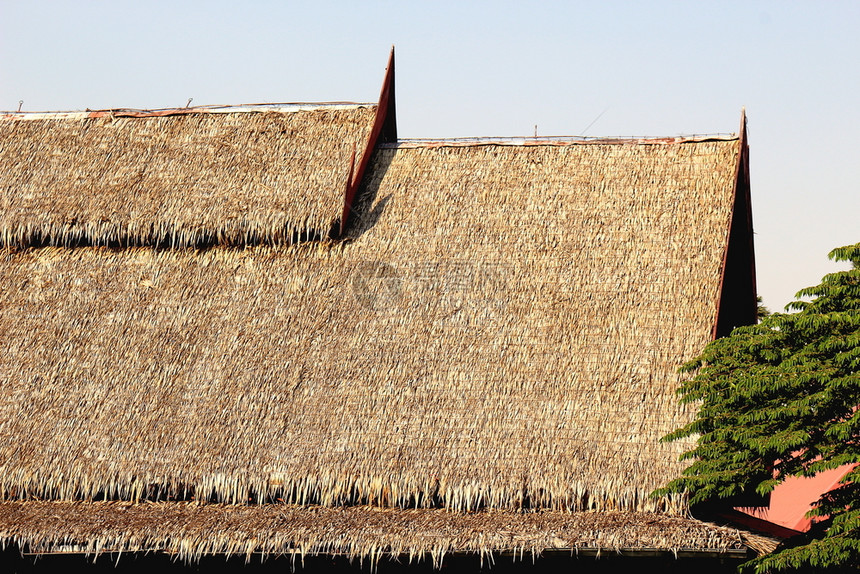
(0, 502, 760, 566)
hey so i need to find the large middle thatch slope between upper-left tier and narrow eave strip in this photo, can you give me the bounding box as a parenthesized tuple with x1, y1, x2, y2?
(0, 140, 739, 511)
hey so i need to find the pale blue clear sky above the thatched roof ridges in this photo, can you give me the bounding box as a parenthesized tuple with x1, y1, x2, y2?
(0, 0, 860, 309)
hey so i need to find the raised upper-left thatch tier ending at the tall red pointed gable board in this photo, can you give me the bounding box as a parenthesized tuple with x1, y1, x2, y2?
(0, 105, 376, 246)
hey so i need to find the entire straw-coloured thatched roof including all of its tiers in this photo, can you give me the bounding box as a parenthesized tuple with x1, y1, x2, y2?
(0, 59, 754, 557)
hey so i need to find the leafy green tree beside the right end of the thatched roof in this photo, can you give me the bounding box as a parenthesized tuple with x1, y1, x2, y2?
(659, 243, 860, 573)
